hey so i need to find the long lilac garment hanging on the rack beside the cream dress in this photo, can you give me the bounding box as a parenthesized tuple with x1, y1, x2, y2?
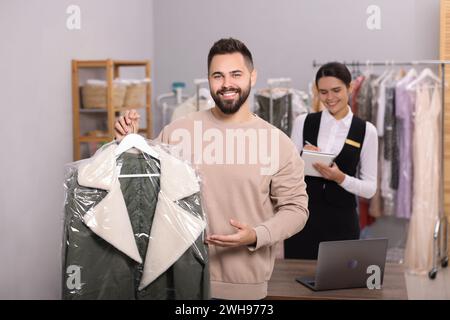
(395, 75, 416, 219)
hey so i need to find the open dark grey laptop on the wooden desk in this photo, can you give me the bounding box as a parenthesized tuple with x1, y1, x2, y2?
(296, 238, 388, 291)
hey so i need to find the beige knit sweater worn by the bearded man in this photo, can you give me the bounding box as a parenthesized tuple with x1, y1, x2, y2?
(158, 110, 308, 299)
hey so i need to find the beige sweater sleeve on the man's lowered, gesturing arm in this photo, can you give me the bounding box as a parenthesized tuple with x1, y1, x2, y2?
(250, 144, 309, 250)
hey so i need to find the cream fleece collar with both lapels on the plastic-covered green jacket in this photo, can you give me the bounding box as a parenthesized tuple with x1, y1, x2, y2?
(78, 144, 206, 290)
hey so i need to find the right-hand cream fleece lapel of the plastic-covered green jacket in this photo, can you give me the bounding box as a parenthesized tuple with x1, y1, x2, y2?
(139, 147, 206, 290)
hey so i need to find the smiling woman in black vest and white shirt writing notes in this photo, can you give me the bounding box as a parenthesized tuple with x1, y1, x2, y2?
(285, 62, 378, 259)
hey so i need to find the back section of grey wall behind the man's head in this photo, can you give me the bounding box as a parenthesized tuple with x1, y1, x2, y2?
(154, 0, 439, 130)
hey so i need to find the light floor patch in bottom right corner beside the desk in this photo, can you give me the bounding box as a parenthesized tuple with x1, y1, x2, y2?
(405, 267, 450, 300)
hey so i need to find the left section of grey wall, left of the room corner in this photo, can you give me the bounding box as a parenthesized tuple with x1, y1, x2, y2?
(0, 0, 153, 299)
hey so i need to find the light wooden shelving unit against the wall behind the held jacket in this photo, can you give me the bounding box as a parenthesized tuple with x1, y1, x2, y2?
(72, 59, 152, 161)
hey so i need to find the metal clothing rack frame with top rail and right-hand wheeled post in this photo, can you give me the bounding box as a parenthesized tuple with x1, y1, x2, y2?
(313, 60, 450, 279)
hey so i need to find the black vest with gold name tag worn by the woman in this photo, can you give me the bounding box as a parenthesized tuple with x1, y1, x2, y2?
(303, 112, 366, 208)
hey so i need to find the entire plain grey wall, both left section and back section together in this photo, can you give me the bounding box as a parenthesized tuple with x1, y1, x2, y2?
(0, 0, 439, 299)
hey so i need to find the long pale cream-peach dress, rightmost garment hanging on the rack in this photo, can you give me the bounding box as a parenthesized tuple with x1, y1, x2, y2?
(405, 85, 442, 274)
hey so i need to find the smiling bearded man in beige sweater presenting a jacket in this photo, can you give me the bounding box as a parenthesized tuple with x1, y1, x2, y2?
(116, 38, 308, 299)
